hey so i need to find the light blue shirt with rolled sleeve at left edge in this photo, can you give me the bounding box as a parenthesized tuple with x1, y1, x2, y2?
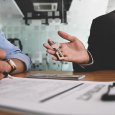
(0, 32, 31, 71)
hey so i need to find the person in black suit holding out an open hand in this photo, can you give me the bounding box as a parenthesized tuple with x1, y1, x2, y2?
(44, 11, 115, 71)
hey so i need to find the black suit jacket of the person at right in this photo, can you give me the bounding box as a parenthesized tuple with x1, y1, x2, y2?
(73, 11, 115, 71)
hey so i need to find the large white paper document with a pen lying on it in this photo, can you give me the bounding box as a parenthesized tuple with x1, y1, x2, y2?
(0, 77, 115, 115)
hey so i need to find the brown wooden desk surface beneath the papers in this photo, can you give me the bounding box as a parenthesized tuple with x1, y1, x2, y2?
(0, 70, 115, 115)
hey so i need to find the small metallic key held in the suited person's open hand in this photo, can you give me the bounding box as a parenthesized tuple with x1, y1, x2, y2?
(51, 42, 64, 59)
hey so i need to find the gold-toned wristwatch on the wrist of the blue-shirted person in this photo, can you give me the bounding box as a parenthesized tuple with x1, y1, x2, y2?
(3, 59, 16, 77)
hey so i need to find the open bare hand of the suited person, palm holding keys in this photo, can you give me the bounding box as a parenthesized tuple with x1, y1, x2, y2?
(43, 31, 90, 64)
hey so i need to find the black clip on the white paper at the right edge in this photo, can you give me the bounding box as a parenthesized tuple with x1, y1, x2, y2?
(101, 82, 115, 101)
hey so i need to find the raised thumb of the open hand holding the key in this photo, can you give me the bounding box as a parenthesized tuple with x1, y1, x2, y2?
(58, 31, 77, 42)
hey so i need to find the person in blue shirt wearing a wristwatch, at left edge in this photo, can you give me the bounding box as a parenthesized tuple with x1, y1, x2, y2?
(0, 32, 31, 78)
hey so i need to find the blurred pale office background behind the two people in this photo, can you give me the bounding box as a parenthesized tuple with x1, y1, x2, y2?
(0, 0, 115, 71)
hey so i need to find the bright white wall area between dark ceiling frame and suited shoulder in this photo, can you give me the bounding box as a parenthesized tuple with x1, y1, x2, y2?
(65, 0, 108, 47)
